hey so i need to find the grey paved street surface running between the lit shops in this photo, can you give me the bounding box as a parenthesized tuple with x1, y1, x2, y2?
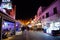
(2, 31, 60, 40)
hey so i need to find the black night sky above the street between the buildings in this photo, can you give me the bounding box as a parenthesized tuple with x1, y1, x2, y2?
(13, 0, 54, 20)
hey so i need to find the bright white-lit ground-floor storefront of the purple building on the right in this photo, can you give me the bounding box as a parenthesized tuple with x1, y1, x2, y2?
(42, 15, 60, 34)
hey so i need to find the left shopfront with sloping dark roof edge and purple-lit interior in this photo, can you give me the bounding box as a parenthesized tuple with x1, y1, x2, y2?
(0, 11, 15, 39)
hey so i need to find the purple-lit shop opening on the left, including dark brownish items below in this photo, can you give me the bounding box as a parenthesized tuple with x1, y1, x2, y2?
(2, 20, 15, 37)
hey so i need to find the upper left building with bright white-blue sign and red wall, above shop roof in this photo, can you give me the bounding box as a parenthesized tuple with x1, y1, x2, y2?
(0, 0, 16, 19)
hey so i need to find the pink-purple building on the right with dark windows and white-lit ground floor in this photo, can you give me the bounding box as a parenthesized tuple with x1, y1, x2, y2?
(39, 0, 60, 33)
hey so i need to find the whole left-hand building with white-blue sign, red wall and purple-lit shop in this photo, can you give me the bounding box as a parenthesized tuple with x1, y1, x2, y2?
(0, 0, 16, 40)
